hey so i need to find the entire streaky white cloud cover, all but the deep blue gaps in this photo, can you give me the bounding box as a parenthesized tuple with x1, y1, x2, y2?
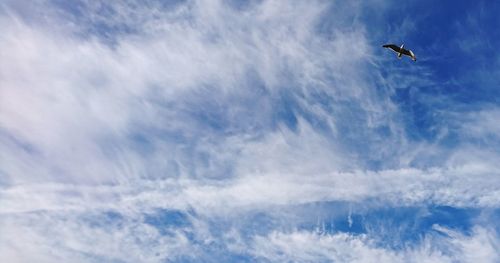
(0, 1, 500, 262)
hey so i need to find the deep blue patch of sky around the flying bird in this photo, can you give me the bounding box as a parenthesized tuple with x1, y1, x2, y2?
(366, 1, 500, 146)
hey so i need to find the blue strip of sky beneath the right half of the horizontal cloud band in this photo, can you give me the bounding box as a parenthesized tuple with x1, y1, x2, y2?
(292, 203, 480, 249)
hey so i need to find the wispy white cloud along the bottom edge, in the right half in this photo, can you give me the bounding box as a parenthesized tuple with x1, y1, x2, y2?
(253, 228, 499, 262)
